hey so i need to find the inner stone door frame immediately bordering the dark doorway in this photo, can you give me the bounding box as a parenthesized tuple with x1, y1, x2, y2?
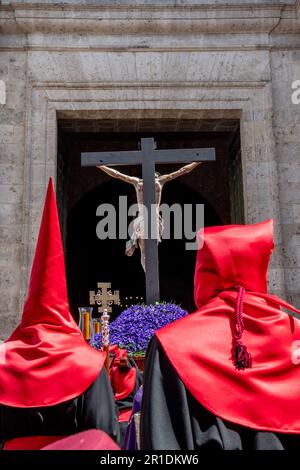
(20, 82, 284, 322)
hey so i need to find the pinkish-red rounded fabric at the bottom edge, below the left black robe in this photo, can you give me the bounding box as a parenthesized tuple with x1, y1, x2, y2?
(41, 429, 120, 450)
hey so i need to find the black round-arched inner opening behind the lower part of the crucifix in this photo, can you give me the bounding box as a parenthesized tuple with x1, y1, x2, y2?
(66, 180, 221, 320)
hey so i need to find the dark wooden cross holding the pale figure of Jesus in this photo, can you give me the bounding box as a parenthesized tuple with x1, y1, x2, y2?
(81, 138, 215, 304)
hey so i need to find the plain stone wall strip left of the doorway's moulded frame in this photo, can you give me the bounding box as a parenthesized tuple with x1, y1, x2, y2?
(0, 50, 27, 338)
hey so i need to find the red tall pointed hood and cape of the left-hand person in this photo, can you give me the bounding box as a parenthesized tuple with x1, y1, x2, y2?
(0, 180, 105, 407)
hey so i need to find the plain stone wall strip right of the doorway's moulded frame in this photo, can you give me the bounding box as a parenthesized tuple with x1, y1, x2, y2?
(271, 50, 300, 307)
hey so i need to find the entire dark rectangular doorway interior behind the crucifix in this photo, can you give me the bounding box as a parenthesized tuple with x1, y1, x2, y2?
(58, 116, 243, 317)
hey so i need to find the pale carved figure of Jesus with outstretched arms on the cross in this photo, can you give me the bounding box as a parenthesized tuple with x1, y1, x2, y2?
(97, 162, 201, 271)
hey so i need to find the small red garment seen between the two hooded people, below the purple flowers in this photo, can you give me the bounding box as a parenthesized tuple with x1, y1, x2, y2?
(110, 346, 136, 400)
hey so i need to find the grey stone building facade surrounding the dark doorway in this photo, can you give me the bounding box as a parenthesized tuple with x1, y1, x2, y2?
(0, 0, 300, 339)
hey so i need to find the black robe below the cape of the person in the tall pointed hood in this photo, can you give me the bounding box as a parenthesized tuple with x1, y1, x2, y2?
(0, 368, 120, 444)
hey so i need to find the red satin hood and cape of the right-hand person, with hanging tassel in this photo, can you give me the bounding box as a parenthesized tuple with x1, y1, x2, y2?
(156, 221, 300, 433)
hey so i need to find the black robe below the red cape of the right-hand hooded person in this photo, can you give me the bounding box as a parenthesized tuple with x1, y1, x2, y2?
(141, 337, 300, 450)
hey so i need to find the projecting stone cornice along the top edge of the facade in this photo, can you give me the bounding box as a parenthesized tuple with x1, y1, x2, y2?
(0, 0, 300, 35)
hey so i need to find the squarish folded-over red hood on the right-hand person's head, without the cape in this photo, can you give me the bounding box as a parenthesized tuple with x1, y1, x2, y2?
(194, 220, 274, 308)
